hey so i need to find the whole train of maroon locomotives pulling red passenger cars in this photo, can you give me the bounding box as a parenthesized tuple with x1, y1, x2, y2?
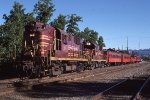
(17, 22, 140, 77)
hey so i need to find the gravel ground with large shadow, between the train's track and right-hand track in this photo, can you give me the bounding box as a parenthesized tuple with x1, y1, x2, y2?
(0, 62, 150, 100)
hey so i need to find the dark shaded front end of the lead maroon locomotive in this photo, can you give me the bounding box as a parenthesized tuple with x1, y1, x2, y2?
(22, 22, 45, 57)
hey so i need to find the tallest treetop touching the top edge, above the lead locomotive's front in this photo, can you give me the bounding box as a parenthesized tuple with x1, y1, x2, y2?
(34, 0, 55, 23)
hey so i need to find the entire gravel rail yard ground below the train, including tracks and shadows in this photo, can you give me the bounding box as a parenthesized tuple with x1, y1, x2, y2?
(0, 62, 150, 100)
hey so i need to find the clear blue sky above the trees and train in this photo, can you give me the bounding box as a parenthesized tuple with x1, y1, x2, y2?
(0, 0, 150, 49)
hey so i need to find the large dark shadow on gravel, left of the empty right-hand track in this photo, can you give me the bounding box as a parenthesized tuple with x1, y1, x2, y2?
(15, 82, 118, 98)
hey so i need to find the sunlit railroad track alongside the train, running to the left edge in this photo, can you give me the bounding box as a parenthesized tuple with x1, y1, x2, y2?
(0, 65, 148, 95)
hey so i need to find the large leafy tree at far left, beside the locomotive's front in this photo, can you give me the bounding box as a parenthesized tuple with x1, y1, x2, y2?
(0, 2, 34, 58)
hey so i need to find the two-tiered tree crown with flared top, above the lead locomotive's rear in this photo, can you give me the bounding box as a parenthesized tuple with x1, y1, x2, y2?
(66, 14, 82, 35)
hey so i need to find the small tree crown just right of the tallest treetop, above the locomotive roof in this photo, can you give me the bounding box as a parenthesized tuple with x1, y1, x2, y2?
(51, 14, 67, 30)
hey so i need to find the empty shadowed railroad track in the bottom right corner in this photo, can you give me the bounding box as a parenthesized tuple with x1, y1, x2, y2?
(91, 76, 150, 100)
